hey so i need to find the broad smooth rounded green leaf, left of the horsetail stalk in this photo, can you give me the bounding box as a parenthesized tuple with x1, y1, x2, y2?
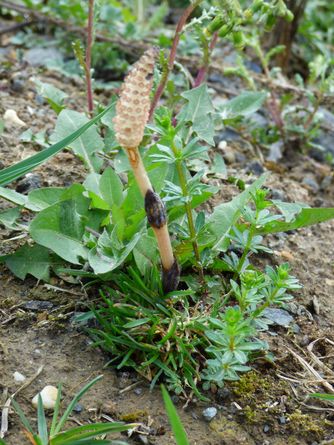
(29, 196, 89, 264)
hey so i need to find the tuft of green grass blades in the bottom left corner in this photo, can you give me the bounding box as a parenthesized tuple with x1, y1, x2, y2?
(10, 376, 135, 445)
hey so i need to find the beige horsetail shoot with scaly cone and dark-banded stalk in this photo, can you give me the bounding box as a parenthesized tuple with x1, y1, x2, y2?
(113, 48, 180, 293)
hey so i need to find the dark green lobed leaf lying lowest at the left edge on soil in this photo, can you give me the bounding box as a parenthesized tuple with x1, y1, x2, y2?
(0, 244, 52, 281)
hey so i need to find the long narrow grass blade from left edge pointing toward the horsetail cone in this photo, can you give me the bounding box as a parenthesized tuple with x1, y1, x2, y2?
(0, 104, 114, 186)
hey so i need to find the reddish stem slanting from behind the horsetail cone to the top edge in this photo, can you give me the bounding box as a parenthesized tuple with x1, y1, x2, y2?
(149, 0, 203, 120)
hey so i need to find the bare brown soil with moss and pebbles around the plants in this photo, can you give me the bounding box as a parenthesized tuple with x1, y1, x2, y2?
(0, 28, 334, 445)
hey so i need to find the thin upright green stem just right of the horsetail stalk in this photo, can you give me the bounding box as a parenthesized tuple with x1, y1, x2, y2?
(172, 143, 204, 283)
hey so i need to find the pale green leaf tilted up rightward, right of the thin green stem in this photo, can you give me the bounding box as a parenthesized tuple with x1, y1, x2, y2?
(208, 175, 266, 251)
